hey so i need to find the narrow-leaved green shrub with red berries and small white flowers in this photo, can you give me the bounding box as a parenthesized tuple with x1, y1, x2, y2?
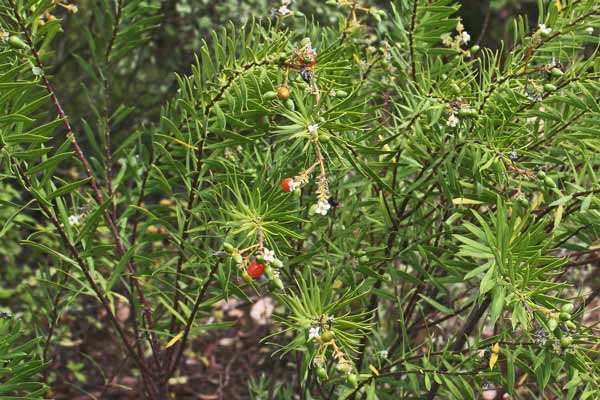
(0, 0, 600, 399)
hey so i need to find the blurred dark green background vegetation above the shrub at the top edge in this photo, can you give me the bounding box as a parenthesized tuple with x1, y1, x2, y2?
(49, 0, 537, 135)
